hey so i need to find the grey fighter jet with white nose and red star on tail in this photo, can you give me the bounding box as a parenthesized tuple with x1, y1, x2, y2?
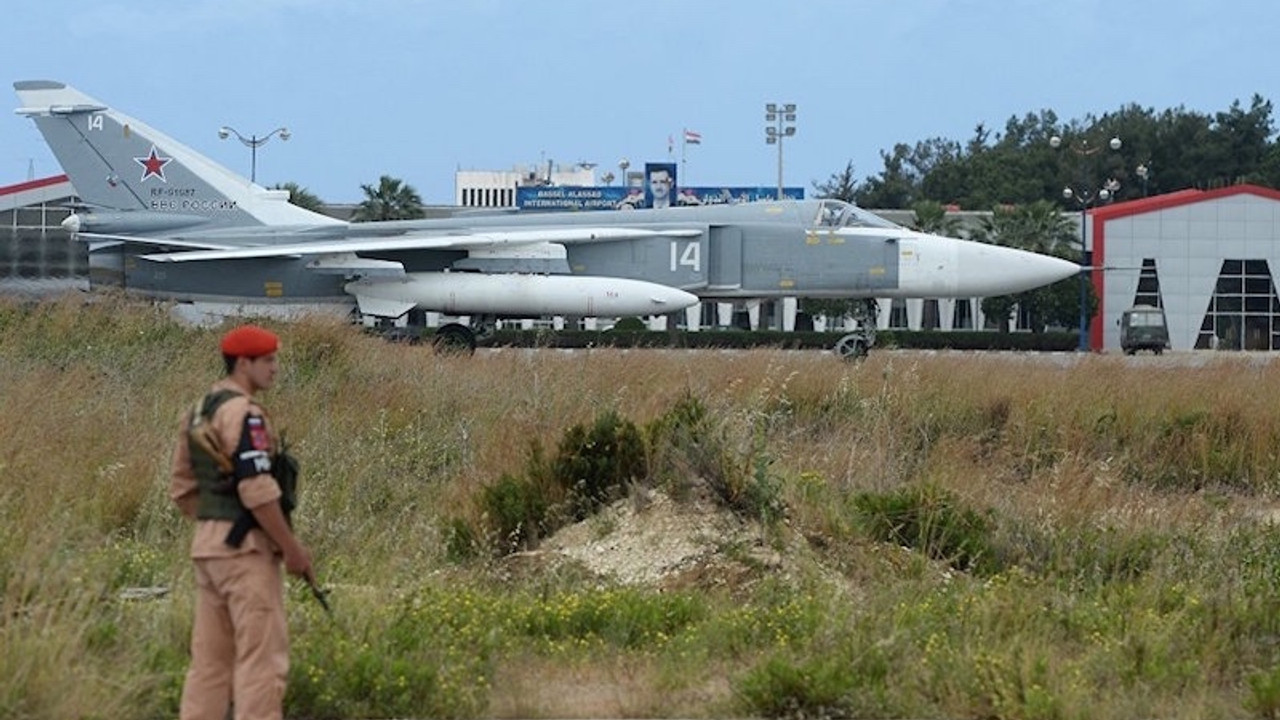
(14, 81, 1080, 354)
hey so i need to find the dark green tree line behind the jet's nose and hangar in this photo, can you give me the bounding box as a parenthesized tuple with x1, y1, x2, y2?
(815, 95, 1280, 210)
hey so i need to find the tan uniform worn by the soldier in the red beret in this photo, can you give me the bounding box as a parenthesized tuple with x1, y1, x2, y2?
(169, 378, 289, 720)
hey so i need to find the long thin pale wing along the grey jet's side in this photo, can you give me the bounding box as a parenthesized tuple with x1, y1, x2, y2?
(138, 227, 703, 263)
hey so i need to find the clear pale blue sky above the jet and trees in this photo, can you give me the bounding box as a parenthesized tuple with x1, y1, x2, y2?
(0, 0, 1280, 202)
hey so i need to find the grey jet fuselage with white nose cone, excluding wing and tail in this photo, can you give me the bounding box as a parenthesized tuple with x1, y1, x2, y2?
(78, 200, 1078, 310)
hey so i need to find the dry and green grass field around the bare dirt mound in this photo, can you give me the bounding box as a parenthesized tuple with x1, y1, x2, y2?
(0, 297, 1280, 719)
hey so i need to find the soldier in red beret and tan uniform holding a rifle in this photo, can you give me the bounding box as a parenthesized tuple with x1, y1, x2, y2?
(169, 325, 314, 720)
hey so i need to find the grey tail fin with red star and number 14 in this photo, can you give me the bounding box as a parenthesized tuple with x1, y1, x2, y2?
(14, 81, 340, 227)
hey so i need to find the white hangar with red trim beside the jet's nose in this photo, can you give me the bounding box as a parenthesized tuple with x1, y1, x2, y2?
(1087, 184, 1280, 351)
